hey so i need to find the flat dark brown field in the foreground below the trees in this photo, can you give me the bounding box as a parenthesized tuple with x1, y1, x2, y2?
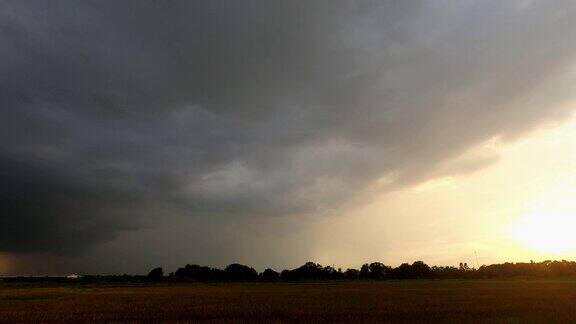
(0, 280, 576, 323)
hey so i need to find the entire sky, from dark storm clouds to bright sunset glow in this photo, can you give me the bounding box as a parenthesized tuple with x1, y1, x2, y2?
(0, 0, 576, 274)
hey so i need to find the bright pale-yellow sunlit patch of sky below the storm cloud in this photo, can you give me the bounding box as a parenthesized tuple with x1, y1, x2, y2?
(302, 111, 576, 265)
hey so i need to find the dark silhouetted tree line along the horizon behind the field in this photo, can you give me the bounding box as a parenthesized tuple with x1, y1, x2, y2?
(146, 260, 576, 281)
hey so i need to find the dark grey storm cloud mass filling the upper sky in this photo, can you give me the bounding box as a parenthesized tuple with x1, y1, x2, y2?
(0, 1, 576, 252)
